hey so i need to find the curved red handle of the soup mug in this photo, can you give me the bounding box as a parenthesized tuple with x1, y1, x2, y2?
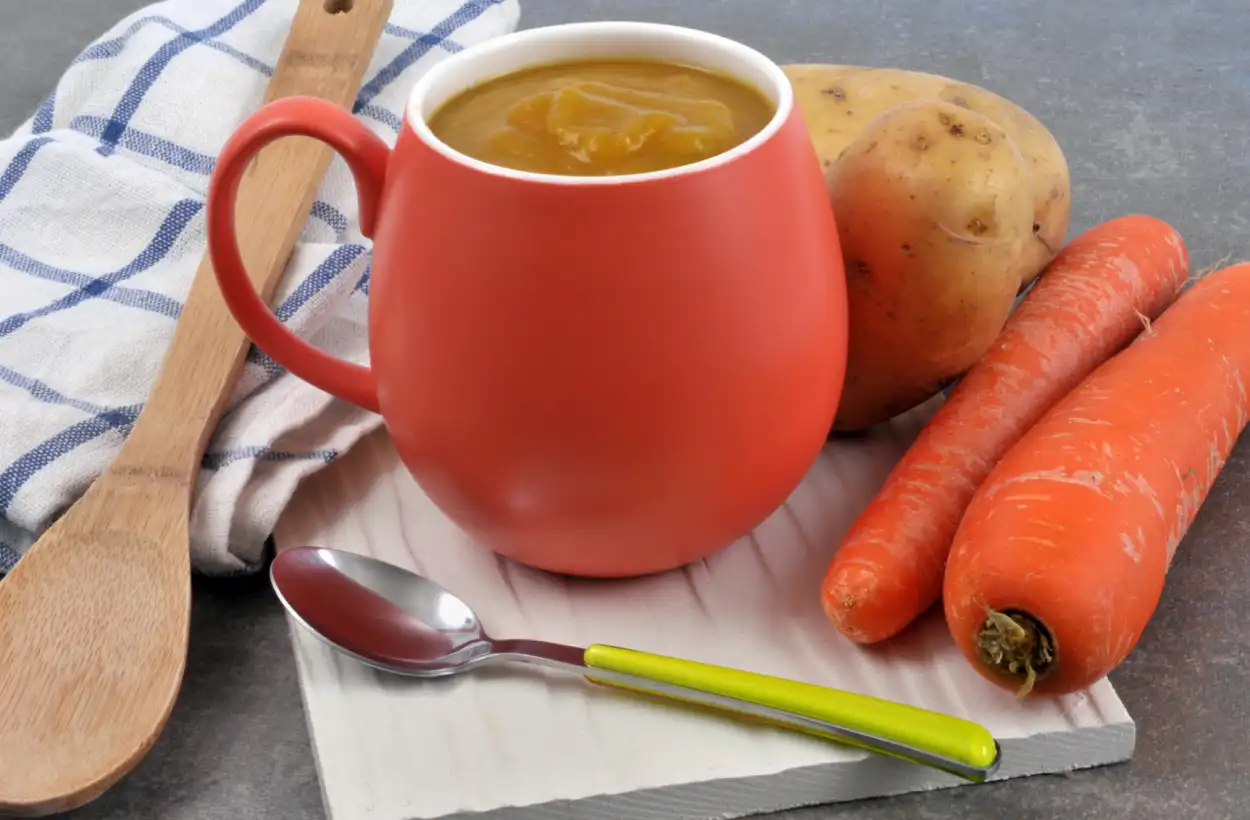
(206, 96, 390, 413)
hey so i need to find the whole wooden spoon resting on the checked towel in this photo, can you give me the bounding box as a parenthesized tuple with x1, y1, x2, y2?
(0, 0, 391, 816)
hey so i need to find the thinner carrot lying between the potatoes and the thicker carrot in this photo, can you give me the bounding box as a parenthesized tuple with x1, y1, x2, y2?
(820, 215, 1189, 644)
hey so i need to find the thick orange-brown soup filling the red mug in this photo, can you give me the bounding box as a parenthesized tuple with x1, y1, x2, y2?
(429, 60, 774, 176)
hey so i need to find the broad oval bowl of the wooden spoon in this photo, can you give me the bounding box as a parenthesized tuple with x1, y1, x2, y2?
(0, 477, 191, 816)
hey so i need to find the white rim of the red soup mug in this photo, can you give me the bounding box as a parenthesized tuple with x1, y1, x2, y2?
(403, 20, 795, 186)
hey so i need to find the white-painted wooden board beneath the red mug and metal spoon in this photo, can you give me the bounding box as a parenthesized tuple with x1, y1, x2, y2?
(276, 407, 1135, 820)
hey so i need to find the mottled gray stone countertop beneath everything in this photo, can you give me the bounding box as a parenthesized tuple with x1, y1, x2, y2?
(0, 0, 1250, 820)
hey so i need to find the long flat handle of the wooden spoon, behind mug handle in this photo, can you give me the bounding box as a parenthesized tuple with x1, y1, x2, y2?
(110, 0, 391, 483)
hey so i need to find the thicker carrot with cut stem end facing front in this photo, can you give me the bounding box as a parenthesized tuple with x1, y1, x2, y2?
(944, 263, 1250, 696)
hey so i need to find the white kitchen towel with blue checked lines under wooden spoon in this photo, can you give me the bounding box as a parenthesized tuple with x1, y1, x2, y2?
(0, 0, 520, 575)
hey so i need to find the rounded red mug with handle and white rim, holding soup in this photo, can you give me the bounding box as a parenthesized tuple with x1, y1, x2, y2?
(208, 23, 846, 576)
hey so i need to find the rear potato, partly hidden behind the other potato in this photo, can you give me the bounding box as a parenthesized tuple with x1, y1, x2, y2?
(783, 65, 1071, 285)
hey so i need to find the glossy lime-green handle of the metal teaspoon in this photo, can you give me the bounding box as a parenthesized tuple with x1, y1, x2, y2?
(583, 644, 999, 783)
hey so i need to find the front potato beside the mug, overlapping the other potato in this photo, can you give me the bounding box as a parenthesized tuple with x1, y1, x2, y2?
(825, 100, 1034, 430)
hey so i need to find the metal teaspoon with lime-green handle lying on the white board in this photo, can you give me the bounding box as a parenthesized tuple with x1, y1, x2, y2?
(270, 546, 1000, 783)
